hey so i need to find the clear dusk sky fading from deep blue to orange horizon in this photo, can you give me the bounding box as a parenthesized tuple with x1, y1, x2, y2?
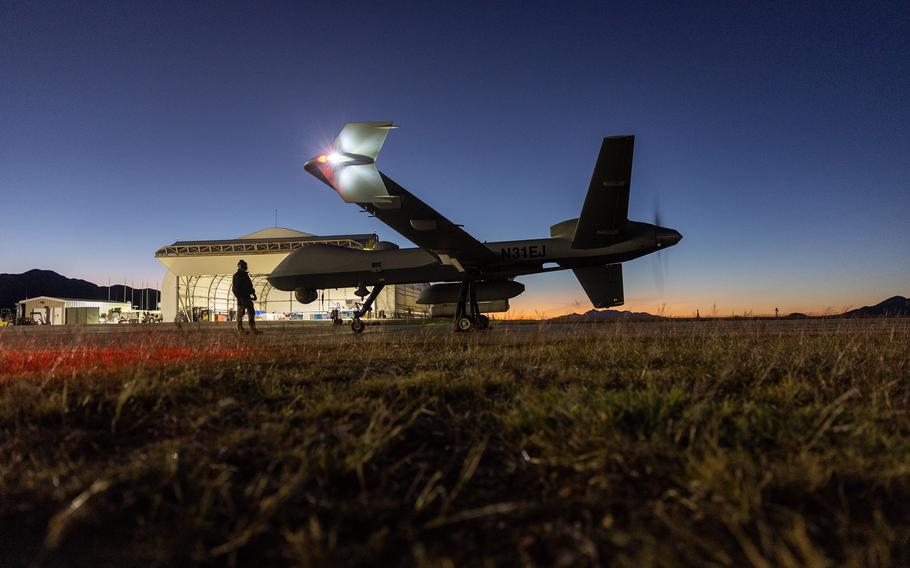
(0, 0, 910, 315)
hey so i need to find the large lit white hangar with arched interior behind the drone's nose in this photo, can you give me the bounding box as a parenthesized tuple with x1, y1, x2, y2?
(155, 227, 429, 322)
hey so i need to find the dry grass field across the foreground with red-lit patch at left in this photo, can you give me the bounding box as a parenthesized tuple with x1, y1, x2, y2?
(0, 319, 910, 568)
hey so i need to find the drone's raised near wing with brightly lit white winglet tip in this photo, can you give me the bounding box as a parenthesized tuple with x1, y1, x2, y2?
(304, 122, 497, 269)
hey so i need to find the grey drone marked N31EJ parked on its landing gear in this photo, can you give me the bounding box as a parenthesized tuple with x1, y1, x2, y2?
(268, 122, 682, 333)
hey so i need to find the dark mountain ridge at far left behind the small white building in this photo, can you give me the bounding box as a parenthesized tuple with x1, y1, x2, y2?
(0, 269, 158, 310)
